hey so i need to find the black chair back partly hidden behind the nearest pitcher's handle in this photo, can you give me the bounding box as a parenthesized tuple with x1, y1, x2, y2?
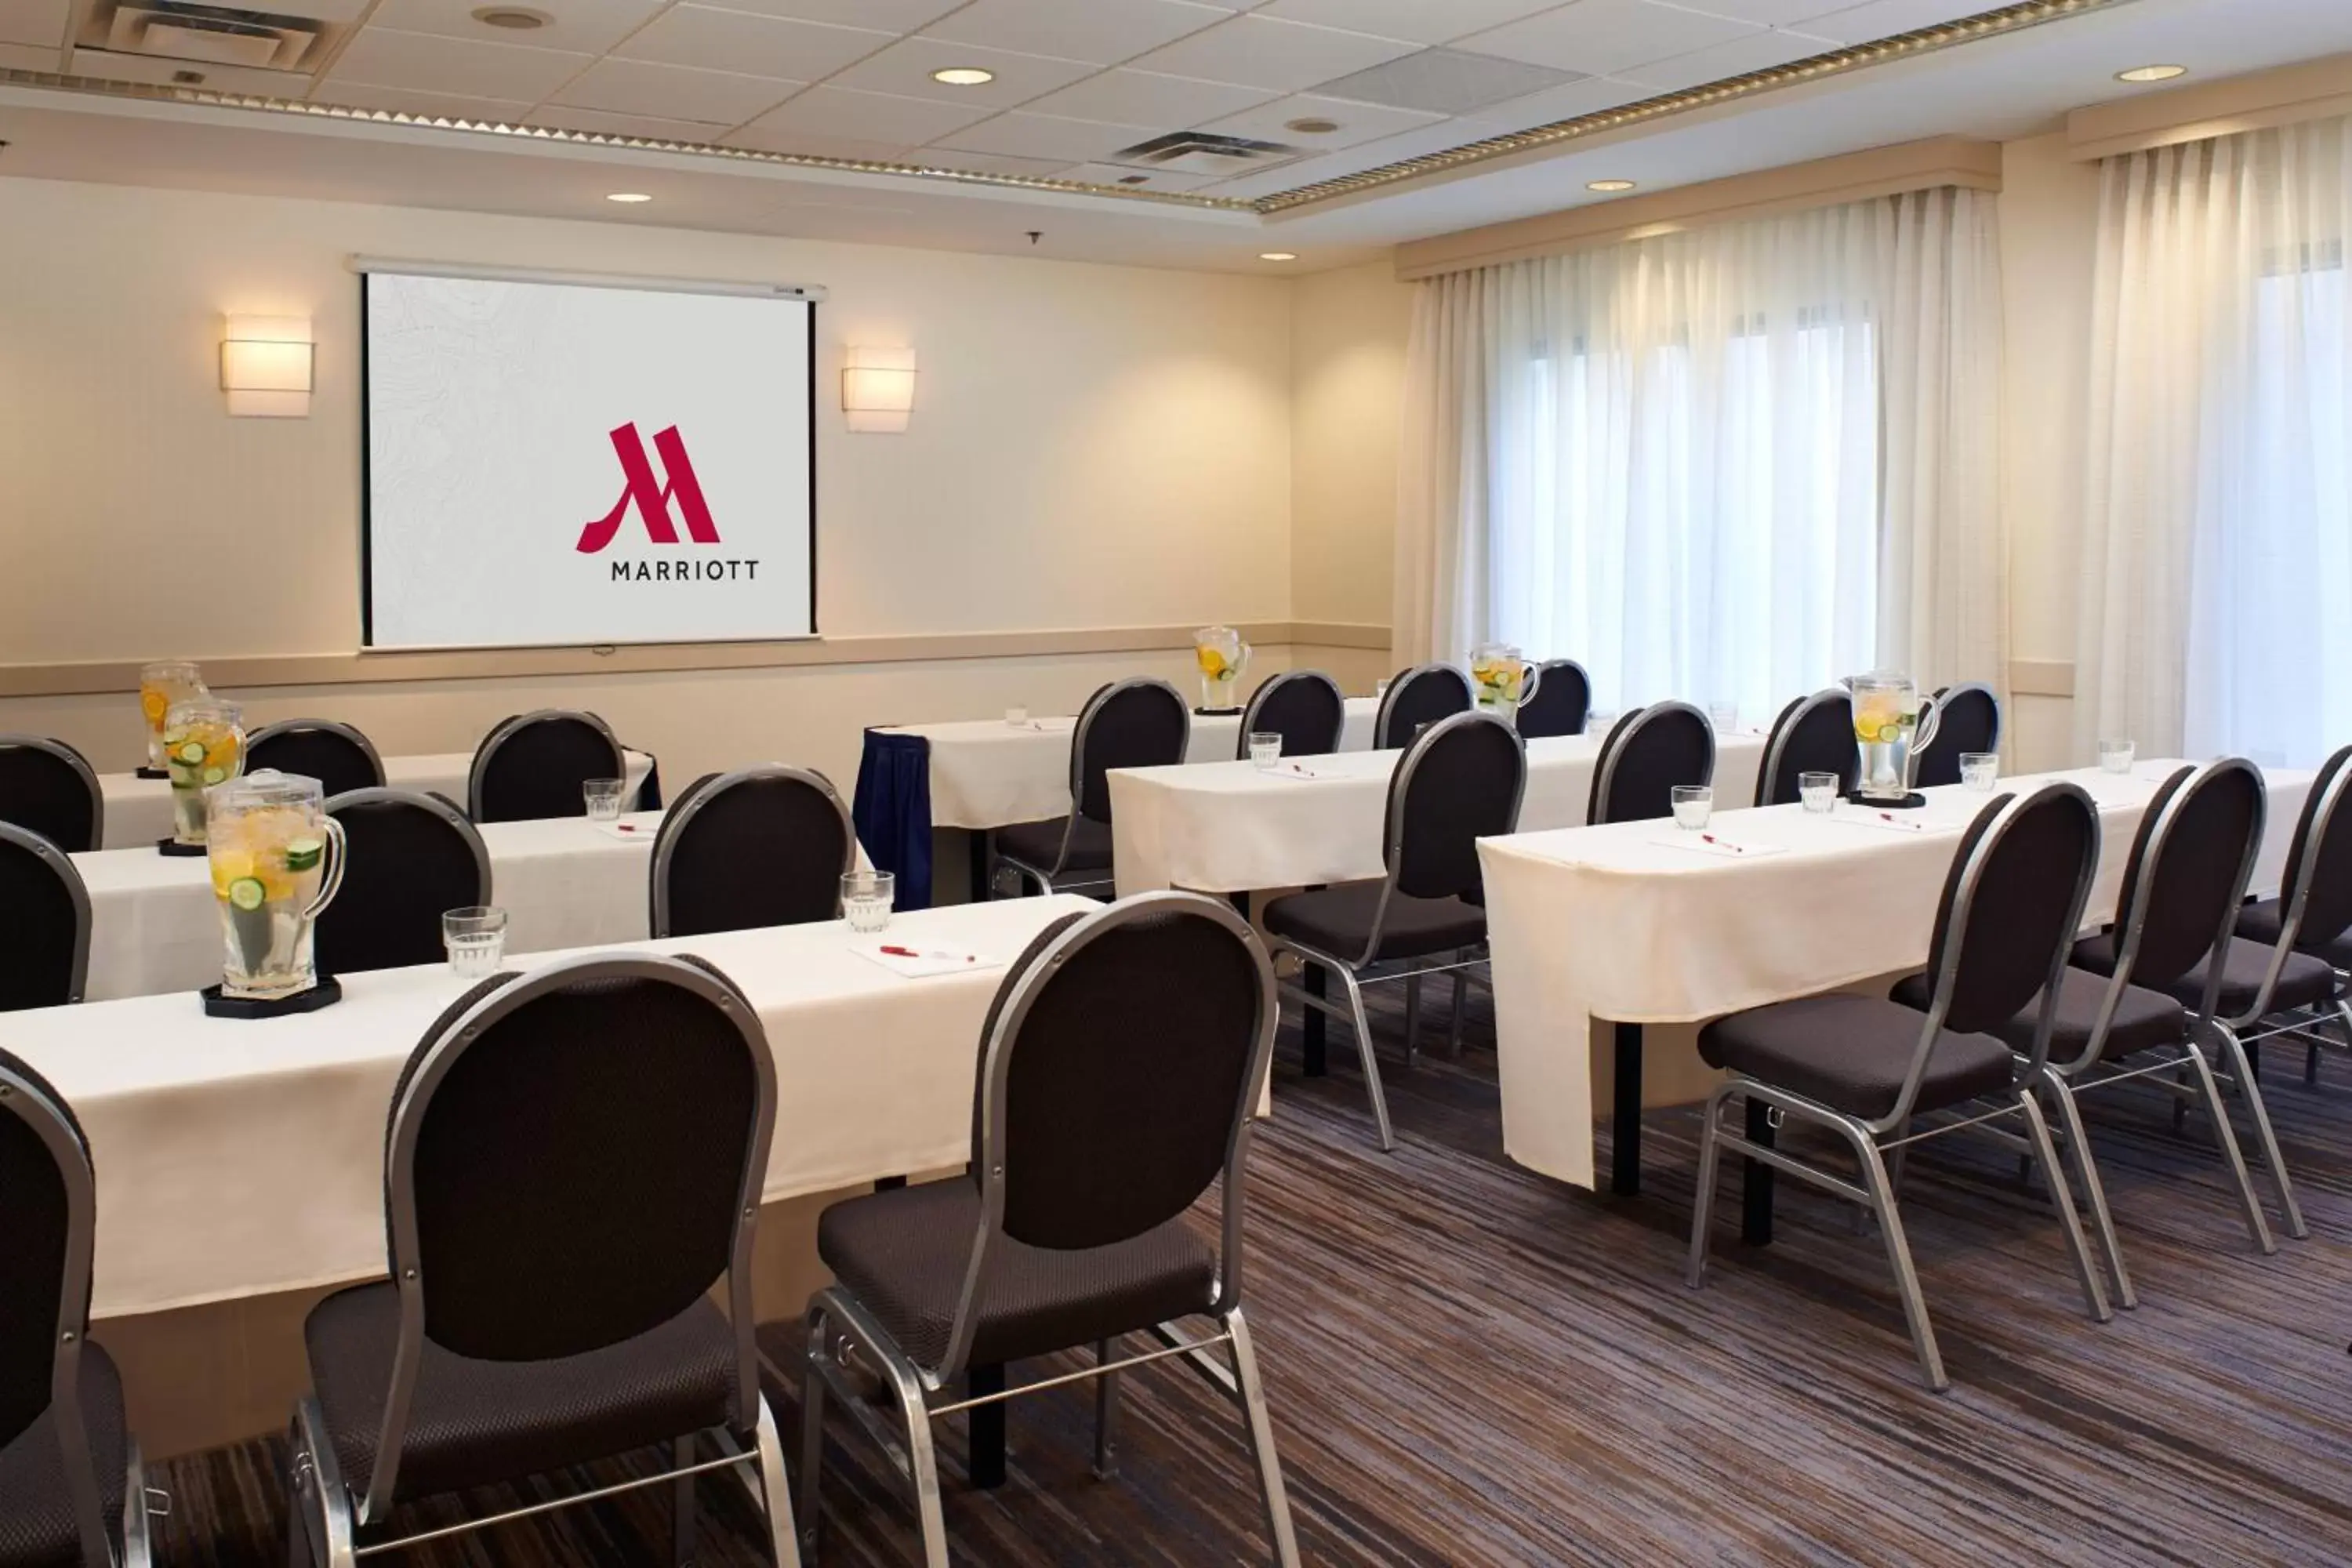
(310, 787, 492, 975)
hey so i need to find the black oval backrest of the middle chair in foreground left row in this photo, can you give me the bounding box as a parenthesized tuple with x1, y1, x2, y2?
(383, 954, 776, 1361)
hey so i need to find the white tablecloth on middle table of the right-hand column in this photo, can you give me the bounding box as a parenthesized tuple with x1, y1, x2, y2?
(1110, 734, 1764, 895)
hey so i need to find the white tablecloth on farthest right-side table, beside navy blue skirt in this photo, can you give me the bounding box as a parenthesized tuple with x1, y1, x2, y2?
(884, 696, 1381, 827)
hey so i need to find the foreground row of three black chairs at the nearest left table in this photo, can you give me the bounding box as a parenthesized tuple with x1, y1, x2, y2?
(0, 893, 1298, 1568)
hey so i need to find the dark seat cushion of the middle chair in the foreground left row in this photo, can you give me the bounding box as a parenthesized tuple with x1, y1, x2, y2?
(303, 1281, 736, 1500)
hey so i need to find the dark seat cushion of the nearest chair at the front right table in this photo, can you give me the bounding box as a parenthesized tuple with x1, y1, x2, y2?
(1698, 994, 2016, 1119)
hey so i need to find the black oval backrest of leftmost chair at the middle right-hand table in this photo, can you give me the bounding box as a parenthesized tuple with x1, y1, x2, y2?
(1383, 713, 1526, 898)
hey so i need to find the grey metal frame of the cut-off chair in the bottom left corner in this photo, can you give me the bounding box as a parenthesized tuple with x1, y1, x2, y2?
(0, 1062, 155, 1568)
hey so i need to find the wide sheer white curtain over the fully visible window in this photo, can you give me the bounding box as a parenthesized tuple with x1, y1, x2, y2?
(1397, 191, 2006, 720)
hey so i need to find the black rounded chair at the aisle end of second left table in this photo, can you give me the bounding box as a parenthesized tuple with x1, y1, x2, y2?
(652, 764, 858, 935)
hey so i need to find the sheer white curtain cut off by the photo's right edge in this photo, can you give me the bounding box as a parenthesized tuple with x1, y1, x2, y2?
(2074, 120, 2352, 767)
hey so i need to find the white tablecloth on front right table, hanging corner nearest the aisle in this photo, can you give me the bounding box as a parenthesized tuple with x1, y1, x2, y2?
(1479, 762, 2312, 1187)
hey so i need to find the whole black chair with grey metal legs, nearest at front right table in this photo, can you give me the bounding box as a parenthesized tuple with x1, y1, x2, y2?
(1689, 783, 2114, 1392)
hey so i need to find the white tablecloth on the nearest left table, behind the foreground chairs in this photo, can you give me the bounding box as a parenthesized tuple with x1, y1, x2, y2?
(0, 895, 1096, 1316)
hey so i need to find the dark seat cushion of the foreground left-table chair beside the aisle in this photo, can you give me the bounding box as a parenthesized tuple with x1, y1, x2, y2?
(816, 1178, 1216, 1368)
